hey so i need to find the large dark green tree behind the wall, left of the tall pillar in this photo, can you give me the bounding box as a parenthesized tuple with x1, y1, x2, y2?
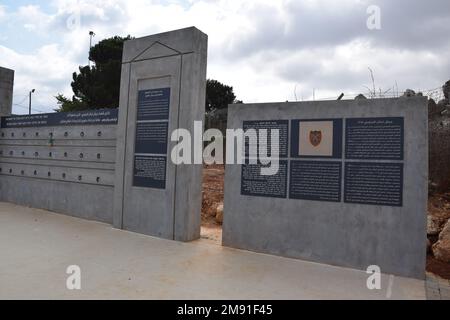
(56, 36, 131, 112)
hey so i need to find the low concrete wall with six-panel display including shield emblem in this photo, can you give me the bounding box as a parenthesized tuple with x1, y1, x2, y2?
(223, 98, 428, 278)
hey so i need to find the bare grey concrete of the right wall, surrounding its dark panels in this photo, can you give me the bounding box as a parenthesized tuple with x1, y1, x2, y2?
(223, 98, 428, 279)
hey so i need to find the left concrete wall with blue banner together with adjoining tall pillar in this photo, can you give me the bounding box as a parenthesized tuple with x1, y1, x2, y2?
(0, 27, 208, 241)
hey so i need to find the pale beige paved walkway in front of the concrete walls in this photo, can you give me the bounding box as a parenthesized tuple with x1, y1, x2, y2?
(0, 203, 425, 299)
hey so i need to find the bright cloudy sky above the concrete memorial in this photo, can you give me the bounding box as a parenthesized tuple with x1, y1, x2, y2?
(0, 0, 450, 114)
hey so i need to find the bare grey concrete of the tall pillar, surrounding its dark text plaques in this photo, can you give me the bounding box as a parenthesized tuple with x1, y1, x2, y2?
(114, 27, 207, 241)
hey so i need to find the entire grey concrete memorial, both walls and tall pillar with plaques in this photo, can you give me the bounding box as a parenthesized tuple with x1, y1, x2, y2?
(0, 27, 428, 278)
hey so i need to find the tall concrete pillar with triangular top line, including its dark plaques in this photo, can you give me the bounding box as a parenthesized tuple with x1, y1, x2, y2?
(114, 27, 208, 241)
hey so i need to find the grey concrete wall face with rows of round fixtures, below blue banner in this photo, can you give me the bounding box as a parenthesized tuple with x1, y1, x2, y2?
(0, 125, 117, 224)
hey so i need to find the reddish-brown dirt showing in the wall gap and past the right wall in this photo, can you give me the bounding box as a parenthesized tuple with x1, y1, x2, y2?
(202, 165, 450, 279)
